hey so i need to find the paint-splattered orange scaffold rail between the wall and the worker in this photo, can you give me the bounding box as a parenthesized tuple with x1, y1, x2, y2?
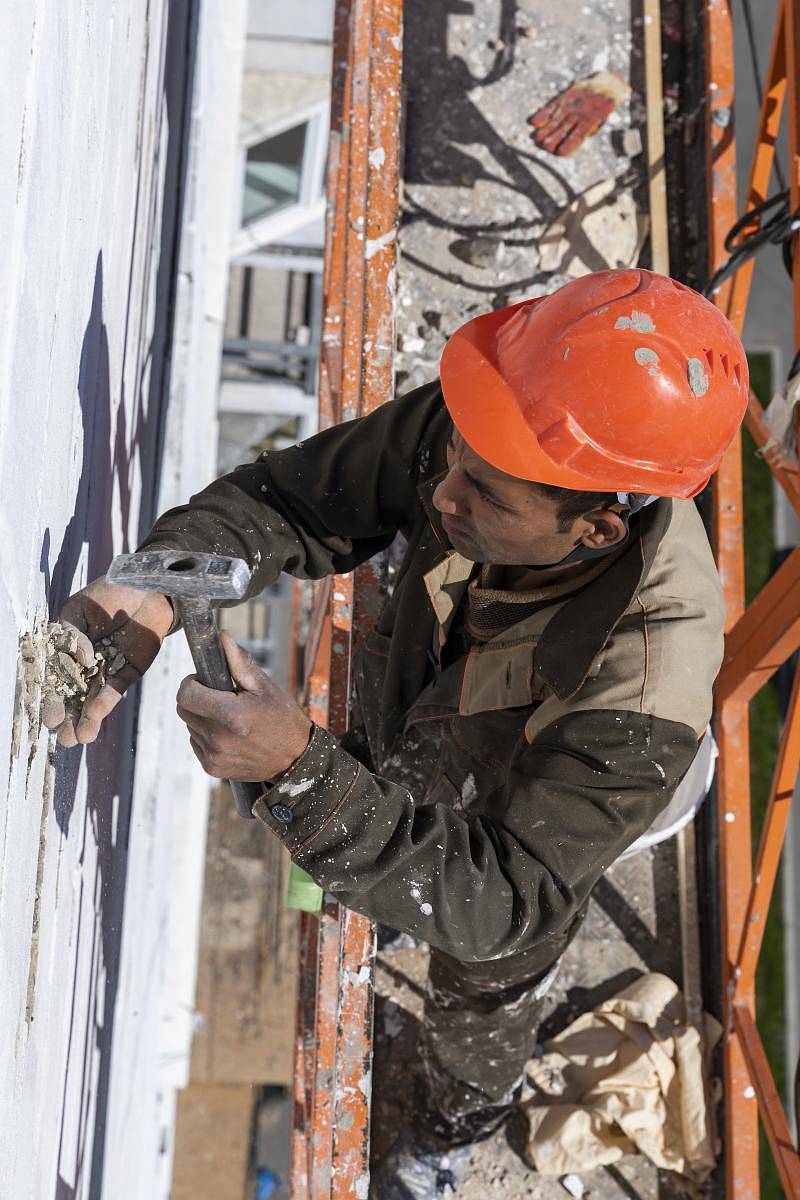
(289, 0, 403, 1200)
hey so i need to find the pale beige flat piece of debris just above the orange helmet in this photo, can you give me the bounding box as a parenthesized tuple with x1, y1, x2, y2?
(539, 179, 648, 277)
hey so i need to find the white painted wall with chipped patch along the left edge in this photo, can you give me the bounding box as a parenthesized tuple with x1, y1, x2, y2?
(0, 0, 243, 1200)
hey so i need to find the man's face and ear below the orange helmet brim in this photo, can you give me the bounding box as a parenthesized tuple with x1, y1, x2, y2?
(433, 430, 626, 566)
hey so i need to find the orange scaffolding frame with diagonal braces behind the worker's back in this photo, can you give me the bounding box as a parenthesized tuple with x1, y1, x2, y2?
(705, 0, 800, 1200)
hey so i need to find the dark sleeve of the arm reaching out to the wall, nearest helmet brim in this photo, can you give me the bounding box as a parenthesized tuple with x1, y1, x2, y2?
(137, 384, 449, 607)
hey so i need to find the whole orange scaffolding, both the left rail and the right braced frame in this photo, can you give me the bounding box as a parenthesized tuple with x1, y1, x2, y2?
(290, 0, 800, 1200)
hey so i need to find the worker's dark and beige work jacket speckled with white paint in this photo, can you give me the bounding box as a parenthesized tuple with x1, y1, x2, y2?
(139, 383, 724, 972)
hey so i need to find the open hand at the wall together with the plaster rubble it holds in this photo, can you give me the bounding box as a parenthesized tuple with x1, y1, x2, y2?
(42, 575, 174, 746)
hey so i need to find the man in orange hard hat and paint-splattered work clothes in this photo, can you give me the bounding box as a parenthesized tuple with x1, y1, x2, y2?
(50, 270, 748, 1200)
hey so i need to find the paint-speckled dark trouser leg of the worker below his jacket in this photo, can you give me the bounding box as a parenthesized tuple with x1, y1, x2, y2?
(414, 948, 559, 1146)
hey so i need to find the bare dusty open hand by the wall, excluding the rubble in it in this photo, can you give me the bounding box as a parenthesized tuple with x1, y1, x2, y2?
(42, 575, 174, 746)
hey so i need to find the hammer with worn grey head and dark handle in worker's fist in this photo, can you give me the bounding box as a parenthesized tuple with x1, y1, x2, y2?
(106, 550, 263, 821)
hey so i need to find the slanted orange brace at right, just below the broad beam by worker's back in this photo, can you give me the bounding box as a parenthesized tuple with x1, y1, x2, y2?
(733, 672, 800, 1004)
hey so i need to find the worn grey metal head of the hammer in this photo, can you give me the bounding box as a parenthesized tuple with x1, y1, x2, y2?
(106, 550, 252, 600)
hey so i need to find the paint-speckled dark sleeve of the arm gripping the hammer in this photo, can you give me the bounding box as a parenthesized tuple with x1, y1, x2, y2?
(253, 709, 697, 966)
